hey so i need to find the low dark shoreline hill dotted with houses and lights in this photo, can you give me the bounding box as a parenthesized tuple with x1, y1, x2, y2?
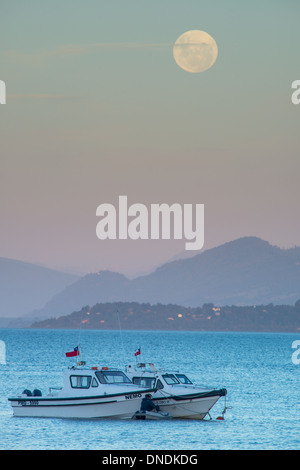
(32, 300, 300, 333)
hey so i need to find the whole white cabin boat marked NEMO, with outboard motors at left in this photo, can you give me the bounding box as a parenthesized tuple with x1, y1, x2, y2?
(9, 366, 153, 419)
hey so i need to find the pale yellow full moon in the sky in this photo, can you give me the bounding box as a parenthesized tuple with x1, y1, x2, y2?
(173, 30, 218, 73)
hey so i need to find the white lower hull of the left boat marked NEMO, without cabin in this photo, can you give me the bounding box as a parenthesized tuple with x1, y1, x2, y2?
(9, 391, 149, 419)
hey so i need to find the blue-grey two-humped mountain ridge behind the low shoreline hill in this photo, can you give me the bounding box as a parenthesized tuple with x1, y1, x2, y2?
(29, 237, 300, 317)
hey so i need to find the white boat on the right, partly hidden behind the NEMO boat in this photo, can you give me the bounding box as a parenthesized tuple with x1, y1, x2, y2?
(126, 363, 227, 420)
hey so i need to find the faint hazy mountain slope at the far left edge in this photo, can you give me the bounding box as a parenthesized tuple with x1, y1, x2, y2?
(0, 258, 78, 321)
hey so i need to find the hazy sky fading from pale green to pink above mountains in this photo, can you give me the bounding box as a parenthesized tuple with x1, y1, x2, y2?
(0, 0, 300, 276)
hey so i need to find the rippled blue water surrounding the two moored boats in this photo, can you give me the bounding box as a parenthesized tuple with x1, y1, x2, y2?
(0, 329, 300, 450)
